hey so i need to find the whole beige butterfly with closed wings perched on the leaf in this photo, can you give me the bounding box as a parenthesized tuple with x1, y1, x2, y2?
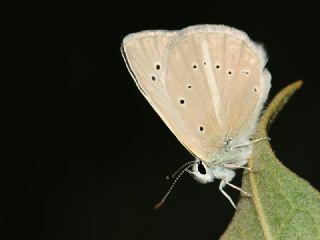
(121, 25, 271, 207)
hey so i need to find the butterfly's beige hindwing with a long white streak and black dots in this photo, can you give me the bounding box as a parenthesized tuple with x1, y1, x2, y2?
(165, 25, 270, 156)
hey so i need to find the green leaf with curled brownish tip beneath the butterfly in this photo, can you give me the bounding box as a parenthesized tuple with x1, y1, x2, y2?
(221, 81, 320, 240)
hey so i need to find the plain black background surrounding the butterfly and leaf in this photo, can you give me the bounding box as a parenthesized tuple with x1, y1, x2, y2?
(0, 1, 320, 239)
